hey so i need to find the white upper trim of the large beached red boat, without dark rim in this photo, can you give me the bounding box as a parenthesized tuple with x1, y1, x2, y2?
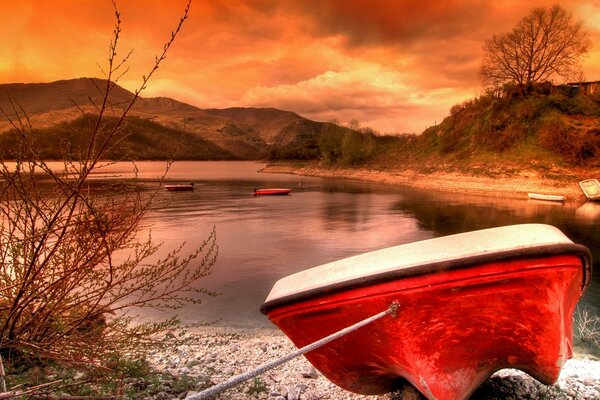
(265, 224, 588, 304)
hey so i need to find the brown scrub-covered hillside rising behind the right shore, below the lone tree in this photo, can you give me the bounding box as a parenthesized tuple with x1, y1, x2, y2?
(368, 93, 600, 173)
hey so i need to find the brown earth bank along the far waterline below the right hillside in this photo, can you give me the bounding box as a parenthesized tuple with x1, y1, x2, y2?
(262, 162, 600, 202)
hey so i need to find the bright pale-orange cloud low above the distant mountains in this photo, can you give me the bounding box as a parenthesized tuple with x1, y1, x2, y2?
(240, 63, 472, 133)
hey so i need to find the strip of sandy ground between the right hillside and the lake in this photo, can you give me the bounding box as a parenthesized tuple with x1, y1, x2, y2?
(263, 164, 600, 201)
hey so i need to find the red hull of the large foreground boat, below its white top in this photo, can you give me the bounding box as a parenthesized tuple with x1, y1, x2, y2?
(267, 254, 588, 400)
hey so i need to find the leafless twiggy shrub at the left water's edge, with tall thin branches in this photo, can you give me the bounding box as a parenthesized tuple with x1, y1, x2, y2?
(0, 2, 217, 372)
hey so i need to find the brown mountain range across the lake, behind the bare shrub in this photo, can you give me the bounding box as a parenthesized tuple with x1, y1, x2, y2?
(0, 78, 327, 160)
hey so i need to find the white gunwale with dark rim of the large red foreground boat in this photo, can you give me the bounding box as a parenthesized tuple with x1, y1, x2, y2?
(260, 224, 592, 314)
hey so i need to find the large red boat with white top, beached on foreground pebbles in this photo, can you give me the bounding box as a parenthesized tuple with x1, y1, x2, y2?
(261, 224, 591, 400)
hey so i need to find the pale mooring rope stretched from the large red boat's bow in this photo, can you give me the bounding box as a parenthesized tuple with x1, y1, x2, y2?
(191, 301, 400, 400)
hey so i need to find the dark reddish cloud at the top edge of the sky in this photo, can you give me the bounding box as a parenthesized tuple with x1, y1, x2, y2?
(288, 0, 494, 47)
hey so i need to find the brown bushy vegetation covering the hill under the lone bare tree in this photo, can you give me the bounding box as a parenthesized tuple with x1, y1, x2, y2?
(406, 93, 600, 165)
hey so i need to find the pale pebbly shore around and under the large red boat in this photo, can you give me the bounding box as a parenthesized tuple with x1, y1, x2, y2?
(148, 327, 600, 400)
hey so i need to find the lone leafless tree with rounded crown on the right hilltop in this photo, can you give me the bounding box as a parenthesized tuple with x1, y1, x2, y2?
(480, 4, 590, 95)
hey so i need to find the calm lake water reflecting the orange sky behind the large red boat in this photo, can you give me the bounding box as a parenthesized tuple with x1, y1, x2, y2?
(99, 162, 600, 328)
